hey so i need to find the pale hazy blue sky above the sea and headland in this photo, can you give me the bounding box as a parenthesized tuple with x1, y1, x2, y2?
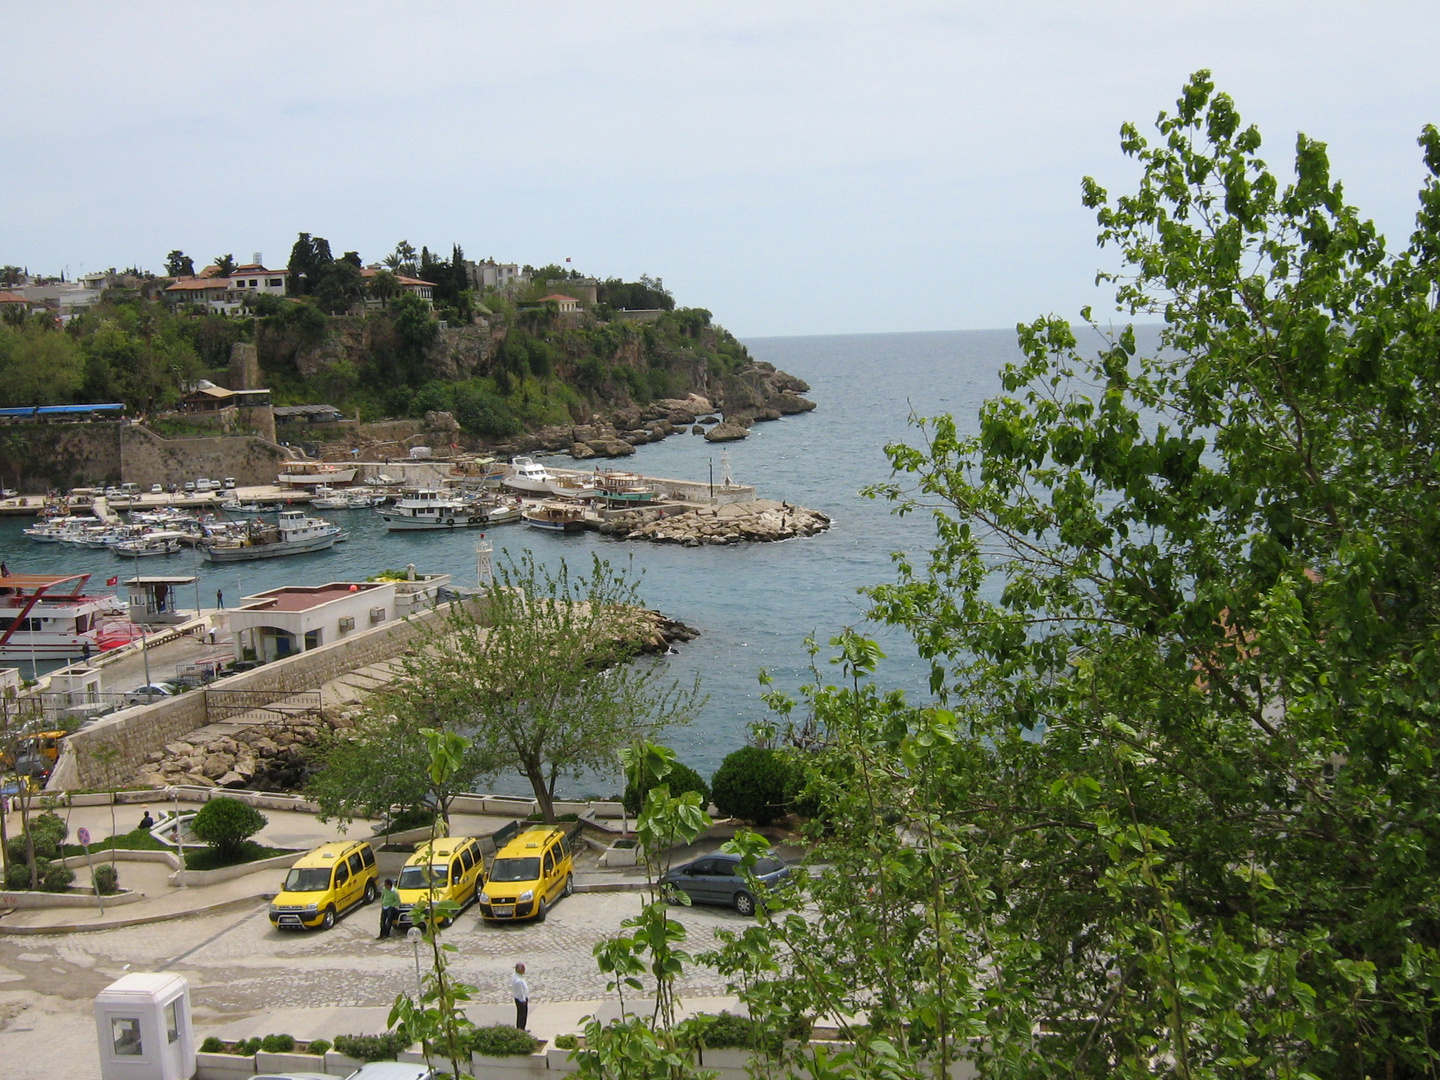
(0, 0, 1440, 337)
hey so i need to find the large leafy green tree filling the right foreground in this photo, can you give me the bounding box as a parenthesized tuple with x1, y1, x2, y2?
(723, 72, 1440, 1080)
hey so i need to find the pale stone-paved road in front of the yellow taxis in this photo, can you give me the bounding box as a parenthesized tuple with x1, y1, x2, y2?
(0, 893, 750, 1080)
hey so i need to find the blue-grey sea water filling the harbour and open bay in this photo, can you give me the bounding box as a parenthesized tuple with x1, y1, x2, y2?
(0, 331, 1036, 789)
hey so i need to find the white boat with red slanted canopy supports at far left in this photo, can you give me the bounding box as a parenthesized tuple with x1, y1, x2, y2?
(0, 573, 132, 661)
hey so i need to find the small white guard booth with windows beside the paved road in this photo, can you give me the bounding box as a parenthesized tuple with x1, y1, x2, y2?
(95, 972, 196, 1080)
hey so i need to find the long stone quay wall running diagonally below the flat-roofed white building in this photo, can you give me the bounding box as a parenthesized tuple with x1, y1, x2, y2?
(64, 608, 480, 788)
